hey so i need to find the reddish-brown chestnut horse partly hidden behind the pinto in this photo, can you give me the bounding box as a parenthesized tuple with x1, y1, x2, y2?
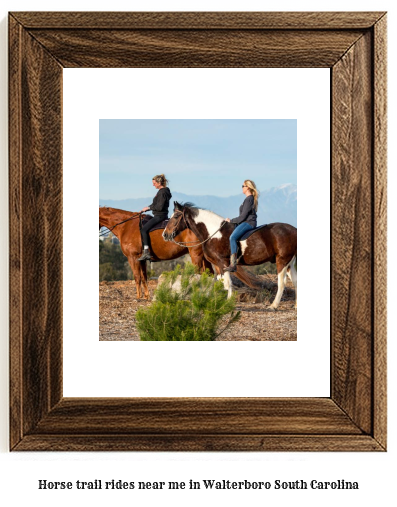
(99, 207, 213, 299)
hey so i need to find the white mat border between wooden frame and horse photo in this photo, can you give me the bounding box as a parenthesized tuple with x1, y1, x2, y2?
(63, 69, 330, 397)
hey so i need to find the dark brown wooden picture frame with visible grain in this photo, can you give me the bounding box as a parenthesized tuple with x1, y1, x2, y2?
(9, 12, 386, 451)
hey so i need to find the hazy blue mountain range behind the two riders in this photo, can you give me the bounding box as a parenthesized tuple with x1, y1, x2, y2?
(99, 183, 297, 227)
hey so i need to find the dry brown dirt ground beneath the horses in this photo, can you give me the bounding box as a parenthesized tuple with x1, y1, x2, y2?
(99, 275, 297, 341)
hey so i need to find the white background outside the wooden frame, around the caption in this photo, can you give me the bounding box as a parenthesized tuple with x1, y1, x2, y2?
(0, 0, 397, 507)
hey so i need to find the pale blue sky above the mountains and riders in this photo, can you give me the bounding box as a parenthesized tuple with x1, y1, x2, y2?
(99, 120, 297, 200)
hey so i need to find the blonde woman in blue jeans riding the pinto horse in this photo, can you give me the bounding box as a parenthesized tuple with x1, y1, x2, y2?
(225, 180, 259, 272)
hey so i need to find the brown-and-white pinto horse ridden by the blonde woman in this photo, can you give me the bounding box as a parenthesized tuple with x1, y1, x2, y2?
(163, 202, 297, 310)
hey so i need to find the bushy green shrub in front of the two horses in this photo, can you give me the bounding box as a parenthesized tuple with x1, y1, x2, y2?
(136, 263, 240, 341)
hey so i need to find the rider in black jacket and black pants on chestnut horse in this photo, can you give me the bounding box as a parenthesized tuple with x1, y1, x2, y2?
(138, 174, 172, 261)
